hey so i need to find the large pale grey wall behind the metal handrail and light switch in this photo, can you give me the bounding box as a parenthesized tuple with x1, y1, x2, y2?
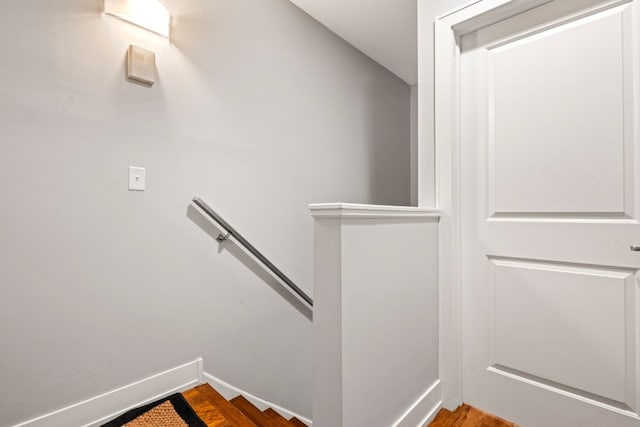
(0, 0, 410, 426)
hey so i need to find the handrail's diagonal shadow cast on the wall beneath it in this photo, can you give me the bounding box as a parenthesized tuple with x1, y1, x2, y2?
(187, 205, 313, 321)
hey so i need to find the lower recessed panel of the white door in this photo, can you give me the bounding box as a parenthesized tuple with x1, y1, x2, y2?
(487, 256, 637, 411)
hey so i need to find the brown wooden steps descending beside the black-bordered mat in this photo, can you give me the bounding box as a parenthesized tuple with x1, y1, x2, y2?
(182, 384, 307, 427)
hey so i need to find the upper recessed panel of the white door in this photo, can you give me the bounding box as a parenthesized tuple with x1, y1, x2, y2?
(488, 4, 634, 219)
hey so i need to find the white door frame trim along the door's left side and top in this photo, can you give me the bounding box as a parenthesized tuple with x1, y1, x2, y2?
(430, 0, 631, 410)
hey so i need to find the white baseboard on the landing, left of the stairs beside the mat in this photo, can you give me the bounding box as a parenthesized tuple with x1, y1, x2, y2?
(14, 359, 202, 427)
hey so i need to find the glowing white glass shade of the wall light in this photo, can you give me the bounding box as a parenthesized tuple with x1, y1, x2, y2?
(104, 0, 171, 38)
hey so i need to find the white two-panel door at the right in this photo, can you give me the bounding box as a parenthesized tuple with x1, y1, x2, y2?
(459, 0, 640, 427)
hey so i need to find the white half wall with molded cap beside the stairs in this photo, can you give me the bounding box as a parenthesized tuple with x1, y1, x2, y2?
(311, 204, 440, 427)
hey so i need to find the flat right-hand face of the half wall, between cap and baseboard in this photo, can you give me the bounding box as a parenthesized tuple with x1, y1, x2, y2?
(342, 218, 438, 427)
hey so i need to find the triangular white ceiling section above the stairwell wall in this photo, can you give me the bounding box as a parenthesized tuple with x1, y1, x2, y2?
(291, 0, 418, 85)
